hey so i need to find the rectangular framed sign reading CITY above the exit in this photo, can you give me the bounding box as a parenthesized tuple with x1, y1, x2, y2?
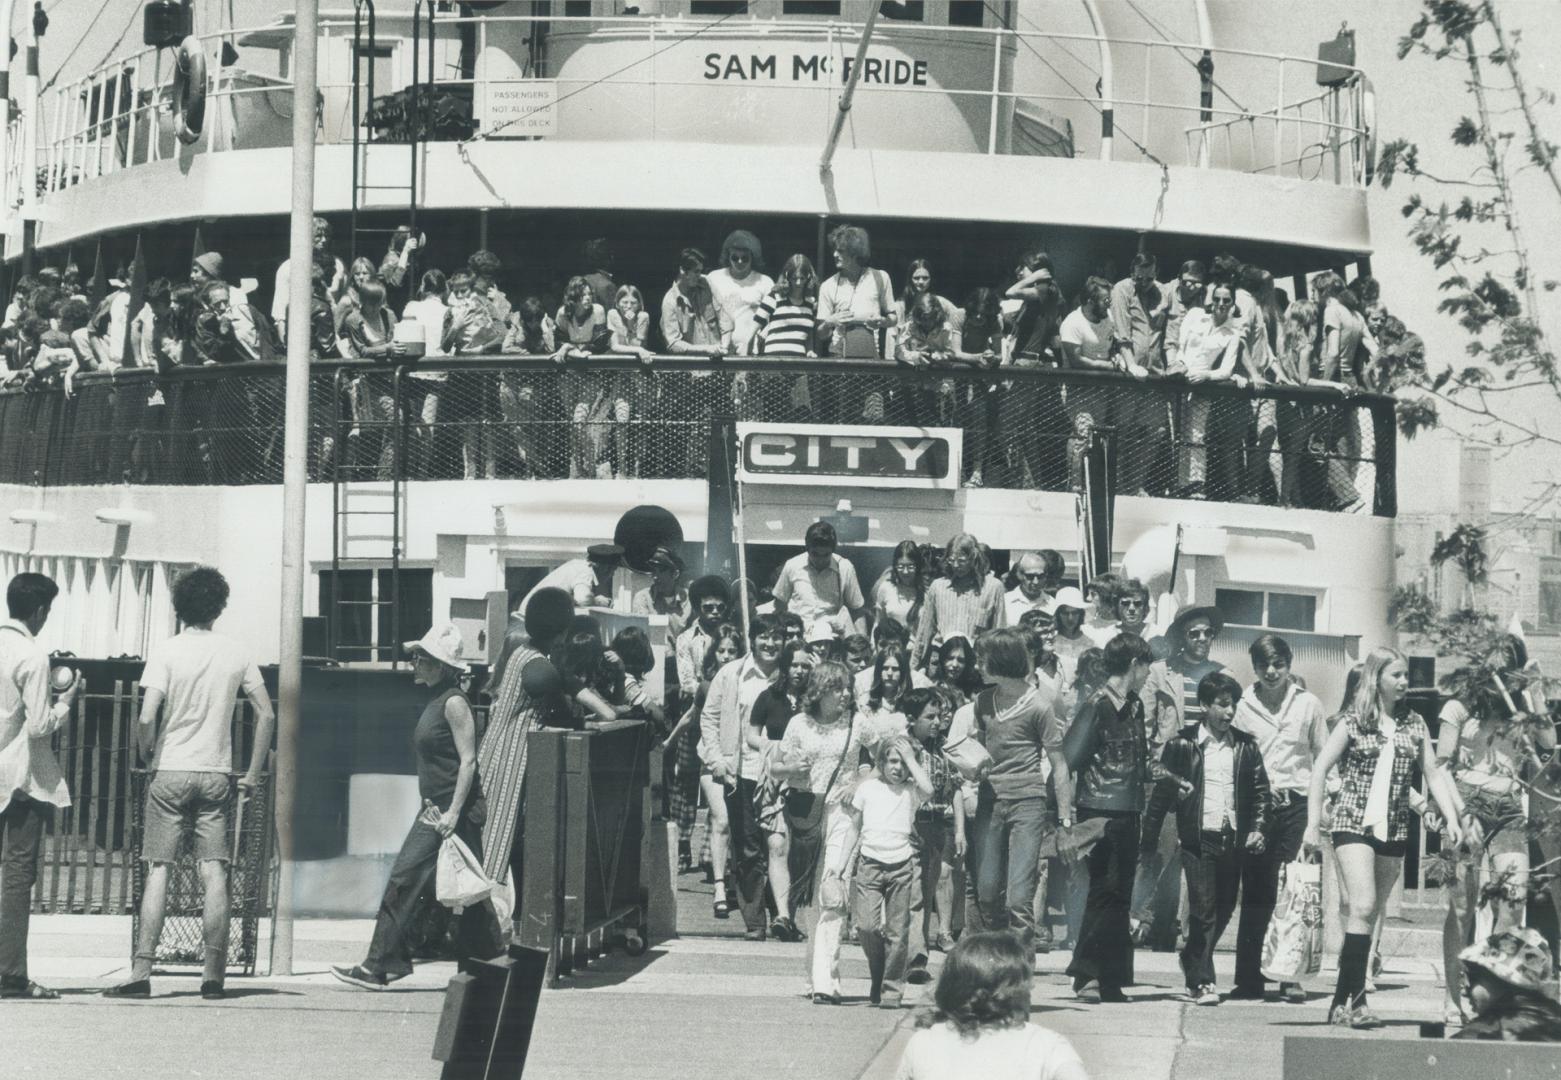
(737, 423, 962, 492)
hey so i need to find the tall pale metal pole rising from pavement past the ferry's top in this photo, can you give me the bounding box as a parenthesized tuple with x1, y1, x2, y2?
(272, 0, 318, 975)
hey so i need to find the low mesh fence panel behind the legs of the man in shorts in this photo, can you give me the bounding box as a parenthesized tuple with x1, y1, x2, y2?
(130, 769, 272, 975)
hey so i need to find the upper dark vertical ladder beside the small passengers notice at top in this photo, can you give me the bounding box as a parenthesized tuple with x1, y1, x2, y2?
(350, 0, 434, 295)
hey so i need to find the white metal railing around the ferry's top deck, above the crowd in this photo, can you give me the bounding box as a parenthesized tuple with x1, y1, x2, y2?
(21, 11, 1375, 194)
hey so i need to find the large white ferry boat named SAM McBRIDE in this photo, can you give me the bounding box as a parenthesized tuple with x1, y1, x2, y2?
(0, 0, 1396, 923)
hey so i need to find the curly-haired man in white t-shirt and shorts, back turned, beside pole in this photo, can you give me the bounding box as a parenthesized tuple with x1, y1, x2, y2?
(103, 567, 273, 1000)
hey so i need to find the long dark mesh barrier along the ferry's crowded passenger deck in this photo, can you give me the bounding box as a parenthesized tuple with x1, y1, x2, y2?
(0, 357, 1396, 513)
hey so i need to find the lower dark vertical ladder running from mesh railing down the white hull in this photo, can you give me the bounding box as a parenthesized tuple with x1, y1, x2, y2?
(325, 367, 406, 668)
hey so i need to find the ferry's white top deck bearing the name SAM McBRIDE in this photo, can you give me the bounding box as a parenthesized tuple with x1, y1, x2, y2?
(5, 0, 1374, 257)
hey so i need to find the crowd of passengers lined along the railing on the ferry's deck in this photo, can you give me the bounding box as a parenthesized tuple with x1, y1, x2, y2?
(0, 218, 1417, 509)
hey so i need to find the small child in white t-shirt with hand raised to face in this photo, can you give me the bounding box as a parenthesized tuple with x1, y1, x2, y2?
(848, 735, 932, 1008)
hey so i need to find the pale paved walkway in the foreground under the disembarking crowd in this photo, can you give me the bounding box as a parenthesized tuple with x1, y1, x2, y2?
(0, 876, 1439, 1080)
